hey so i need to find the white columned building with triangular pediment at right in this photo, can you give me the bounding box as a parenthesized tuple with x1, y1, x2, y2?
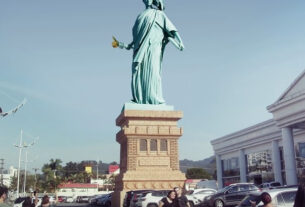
(211, 71, 305, 187)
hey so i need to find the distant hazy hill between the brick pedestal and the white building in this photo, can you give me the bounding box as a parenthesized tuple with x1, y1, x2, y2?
(180, 156, 216, 175)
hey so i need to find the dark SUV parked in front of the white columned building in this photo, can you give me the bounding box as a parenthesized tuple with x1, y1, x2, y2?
(204, 183, 260, 207)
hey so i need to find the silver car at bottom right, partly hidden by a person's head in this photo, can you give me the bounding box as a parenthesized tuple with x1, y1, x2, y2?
(237, 187, 297, 207)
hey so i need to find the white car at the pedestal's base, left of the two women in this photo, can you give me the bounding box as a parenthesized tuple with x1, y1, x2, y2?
(135, 190, 169, 207)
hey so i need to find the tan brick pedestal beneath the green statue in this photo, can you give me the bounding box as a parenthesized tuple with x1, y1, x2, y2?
(112, 110, 186, 207)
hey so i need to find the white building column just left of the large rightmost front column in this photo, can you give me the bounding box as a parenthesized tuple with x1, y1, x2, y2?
(272, 140, 283, 185)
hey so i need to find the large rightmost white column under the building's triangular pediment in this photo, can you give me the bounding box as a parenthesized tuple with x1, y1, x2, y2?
(282, 127, 297, 185)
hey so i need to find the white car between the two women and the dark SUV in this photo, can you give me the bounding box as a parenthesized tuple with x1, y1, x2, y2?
(186, 188, 217, 207)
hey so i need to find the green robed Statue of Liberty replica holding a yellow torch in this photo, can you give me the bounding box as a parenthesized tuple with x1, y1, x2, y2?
(112, 0, 184, 105)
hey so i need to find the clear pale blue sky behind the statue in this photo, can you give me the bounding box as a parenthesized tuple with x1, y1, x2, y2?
(0, 0, 305, 172)
